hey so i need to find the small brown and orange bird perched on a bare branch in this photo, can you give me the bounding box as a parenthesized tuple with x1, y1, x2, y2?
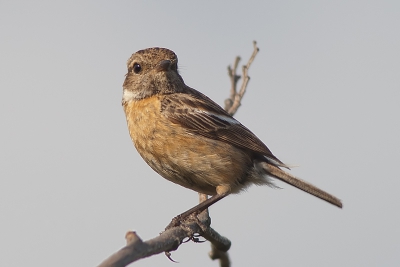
(122, 47, 342, 225)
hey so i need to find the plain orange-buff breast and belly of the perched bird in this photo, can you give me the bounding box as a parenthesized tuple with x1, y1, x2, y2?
(124, 96, 252, 195)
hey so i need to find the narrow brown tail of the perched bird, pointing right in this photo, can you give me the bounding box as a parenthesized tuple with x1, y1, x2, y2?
(261, 162, 343, 208)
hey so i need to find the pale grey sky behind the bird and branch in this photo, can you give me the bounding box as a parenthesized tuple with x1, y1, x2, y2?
(0, 0, 400, 267)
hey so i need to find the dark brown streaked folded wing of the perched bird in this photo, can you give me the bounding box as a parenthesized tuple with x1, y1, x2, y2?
(161, 88, 286, 167)
